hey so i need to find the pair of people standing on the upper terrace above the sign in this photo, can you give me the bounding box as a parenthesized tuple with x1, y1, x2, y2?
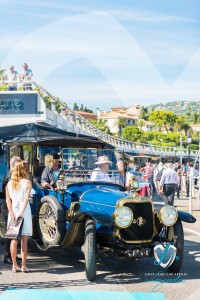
(1, 63, 33, 91)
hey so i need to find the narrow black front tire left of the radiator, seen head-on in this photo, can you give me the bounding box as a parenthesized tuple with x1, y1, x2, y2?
(83, 219, 96, 281)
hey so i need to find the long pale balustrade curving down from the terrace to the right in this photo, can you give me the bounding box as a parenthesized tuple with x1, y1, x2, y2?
(0, 81, 198, 157)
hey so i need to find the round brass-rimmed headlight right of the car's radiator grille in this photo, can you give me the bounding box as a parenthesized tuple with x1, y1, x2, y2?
(160, 205, 178, 226)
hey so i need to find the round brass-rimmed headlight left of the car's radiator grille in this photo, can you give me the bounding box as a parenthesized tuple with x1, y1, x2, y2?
(114, 206, 133, 228)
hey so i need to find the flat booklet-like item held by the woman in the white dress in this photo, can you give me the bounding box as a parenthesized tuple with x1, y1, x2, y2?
(5, 217, 24, 240)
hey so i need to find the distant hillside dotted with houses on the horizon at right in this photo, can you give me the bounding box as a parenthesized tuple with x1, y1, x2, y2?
(146, 101, 200, 115)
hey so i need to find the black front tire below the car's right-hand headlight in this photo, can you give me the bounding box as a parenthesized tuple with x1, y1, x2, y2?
(168, 220, 184, 273)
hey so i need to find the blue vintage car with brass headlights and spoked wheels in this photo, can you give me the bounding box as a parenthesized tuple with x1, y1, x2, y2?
(0, 141, 195, 281)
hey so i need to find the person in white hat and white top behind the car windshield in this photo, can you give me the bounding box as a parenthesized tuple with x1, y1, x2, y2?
(90, 155, 112, 181)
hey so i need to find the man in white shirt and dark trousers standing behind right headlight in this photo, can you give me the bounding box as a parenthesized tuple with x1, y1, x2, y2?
(160, 163, 179, 205)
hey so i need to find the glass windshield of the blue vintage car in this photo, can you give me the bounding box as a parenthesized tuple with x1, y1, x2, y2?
(62, 148, 125, 185)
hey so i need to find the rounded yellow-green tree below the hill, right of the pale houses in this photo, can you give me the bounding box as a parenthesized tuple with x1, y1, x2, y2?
(149, 110, 176, 132)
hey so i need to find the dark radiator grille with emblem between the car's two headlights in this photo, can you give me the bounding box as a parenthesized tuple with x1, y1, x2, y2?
(120, 202, 154, 242)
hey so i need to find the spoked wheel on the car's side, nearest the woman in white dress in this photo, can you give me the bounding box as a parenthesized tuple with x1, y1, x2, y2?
(37, 196, 66, 246)
